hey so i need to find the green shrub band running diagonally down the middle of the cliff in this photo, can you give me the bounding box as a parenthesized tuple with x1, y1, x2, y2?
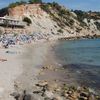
(41, 2, 74, 28)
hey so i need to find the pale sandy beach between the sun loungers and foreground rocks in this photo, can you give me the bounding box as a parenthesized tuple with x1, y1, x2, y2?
(0, 43, 57, 100)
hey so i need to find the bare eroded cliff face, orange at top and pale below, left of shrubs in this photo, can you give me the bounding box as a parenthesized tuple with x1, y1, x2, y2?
(8, 4, 60, 38)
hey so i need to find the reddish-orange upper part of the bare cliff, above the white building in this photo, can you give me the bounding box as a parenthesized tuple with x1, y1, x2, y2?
(8, 4, 43, 19)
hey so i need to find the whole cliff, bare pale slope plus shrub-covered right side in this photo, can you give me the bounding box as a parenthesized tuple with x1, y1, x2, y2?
(0, 3, 100, 38)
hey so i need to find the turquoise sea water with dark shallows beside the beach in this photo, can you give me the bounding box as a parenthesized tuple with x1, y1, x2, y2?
(55, 39, 100, 90)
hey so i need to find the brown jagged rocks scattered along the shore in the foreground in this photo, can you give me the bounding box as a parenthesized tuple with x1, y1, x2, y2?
(11, 67, 100, 100)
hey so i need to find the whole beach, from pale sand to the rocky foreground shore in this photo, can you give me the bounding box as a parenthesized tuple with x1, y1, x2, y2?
(0, 41, 99, 100)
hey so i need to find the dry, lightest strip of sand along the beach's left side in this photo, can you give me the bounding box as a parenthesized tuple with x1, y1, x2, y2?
(0, 46, 22, 100)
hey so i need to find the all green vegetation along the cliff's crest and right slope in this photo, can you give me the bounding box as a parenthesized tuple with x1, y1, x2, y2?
(0, 0, 100, 33)
